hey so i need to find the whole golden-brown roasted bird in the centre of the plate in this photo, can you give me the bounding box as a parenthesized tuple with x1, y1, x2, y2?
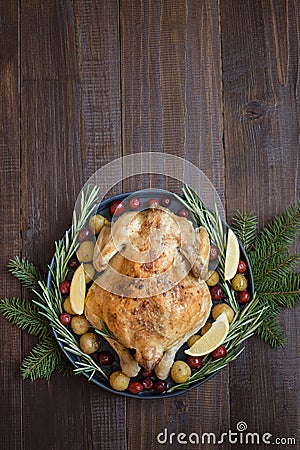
(85, 208, 211, 379)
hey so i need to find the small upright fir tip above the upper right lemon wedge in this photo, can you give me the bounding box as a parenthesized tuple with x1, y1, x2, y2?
(231, 211, 258, 250)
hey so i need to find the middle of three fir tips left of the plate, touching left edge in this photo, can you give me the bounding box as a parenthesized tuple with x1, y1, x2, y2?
(0, 297, 51, 338)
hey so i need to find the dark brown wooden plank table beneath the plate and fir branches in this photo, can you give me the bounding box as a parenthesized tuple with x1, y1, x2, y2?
(0, 0, 300, 450)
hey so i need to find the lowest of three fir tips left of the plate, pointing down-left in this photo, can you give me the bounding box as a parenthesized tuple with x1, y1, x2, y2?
(21, 336, 61, 381)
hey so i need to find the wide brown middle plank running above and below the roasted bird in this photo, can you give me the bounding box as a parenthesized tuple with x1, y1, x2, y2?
(120, 1, 229, 449)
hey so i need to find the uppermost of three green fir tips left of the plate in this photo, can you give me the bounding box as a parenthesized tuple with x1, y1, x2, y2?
(7, 256, 44, 290)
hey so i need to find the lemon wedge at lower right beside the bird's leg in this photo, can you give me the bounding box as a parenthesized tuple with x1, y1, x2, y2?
(184, 313, 229, 356)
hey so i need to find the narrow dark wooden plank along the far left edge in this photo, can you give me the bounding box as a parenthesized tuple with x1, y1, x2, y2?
(0, 0, 22, 449)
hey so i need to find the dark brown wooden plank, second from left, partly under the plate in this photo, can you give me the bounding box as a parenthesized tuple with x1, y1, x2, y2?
(21, 1, 126, 449)
